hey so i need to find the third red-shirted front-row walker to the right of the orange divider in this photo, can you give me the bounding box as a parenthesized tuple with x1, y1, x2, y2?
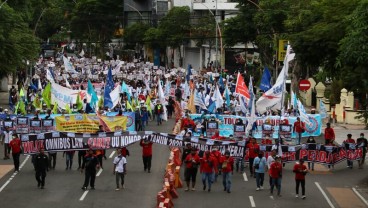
(220, 150, 234, 193)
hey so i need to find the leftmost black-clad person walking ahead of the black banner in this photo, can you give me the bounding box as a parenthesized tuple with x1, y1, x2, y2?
(34, 148, 49, 189)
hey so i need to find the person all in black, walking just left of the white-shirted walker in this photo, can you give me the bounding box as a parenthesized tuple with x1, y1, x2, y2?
(81, 148, 100, 190)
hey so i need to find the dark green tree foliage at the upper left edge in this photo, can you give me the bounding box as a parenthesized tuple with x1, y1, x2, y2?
(0, 4, 40, 78)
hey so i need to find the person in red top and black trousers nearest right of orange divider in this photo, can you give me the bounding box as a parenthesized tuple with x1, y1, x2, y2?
(184, 147, 200, 191)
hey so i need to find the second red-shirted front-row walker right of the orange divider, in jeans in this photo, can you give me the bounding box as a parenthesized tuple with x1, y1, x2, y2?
(200, 151, 216, 192)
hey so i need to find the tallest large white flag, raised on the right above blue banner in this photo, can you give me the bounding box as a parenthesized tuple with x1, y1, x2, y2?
(256, 45, 295, 113)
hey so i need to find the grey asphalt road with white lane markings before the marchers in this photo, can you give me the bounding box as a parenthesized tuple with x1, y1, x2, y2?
(0, 120, 368, 208)
